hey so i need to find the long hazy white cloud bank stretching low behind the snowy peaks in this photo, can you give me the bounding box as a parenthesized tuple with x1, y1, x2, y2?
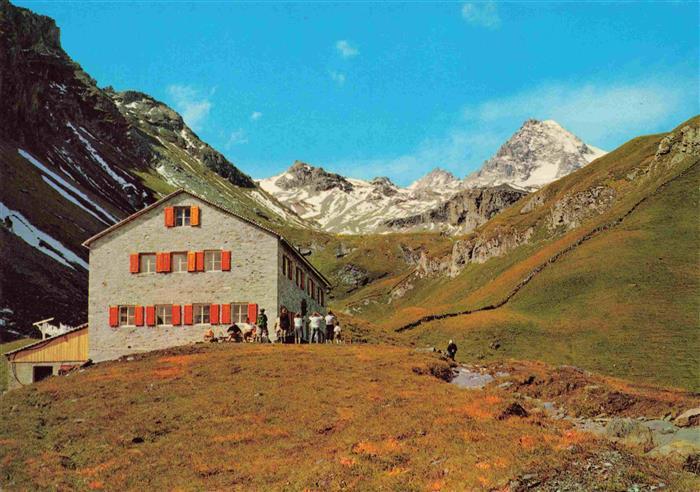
(332, 76, 700, 185)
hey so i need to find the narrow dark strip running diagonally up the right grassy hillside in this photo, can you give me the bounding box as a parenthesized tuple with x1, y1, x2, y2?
(394, 162, 698, 333)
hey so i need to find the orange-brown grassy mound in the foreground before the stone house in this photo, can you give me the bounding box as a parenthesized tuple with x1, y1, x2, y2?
(0, 344, 697, 490)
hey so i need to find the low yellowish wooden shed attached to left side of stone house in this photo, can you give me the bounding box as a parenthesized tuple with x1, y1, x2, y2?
(5, 324, 88, 389)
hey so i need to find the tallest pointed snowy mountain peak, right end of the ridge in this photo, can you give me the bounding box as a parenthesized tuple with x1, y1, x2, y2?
(465, 119, 605, 189)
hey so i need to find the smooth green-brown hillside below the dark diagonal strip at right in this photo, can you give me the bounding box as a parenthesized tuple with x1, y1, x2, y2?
(411, 166, 700, 391)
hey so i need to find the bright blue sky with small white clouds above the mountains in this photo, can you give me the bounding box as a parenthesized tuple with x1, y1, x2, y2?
(14, 1, 700, 185)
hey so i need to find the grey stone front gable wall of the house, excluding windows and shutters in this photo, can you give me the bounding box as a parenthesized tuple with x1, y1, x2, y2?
(88, 193, 281, 361)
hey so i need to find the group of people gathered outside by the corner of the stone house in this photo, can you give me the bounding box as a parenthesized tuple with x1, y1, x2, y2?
(204, 306, 342, 343)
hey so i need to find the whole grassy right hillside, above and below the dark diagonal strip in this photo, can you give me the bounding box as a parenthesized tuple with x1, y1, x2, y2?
(328, 118, 700, 390)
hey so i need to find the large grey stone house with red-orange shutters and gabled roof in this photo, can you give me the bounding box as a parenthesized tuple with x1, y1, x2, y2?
(83, 190, 330, 362)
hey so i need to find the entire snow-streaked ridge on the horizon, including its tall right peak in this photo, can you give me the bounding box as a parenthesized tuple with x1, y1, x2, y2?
(259, 120, 605, 234)
